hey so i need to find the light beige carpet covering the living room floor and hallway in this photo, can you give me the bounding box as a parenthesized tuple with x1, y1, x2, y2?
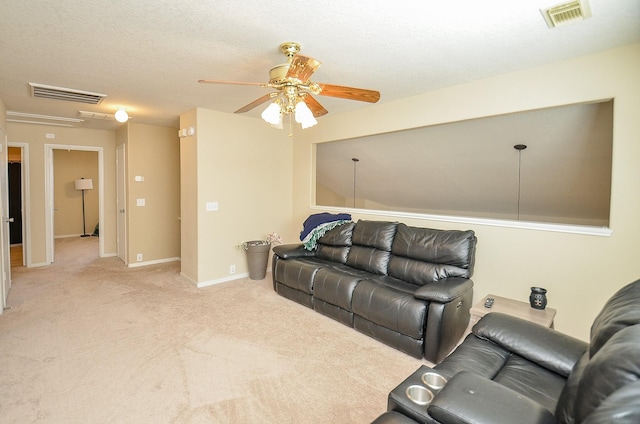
(0, 237, 426, 424)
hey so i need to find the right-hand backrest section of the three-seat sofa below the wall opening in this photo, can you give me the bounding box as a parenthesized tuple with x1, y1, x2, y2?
(388, 224, 477, 285)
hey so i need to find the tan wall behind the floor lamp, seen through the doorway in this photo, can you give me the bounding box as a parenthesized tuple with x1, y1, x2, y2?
(53, 150, 100, 237)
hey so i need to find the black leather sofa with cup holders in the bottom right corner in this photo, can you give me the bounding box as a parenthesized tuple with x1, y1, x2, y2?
(374, 280, 640, 424)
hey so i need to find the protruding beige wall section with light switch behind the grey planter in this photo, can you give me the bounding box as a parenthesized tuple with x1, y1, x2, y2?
(180, 109, 299, 286)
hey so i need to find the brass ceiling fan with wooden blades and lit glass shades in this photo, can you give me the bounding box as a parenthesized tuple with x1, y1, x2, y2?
(198, 42, 380, 128)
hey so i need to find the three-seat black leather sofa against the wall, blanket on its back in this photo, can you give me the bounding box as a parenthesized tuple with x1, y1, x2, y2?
(272, 220, 476, 363)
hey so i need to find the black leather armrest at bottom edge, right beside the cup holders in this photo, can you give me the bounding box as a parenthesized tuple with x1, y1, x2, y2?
(427, 372, 556, 424)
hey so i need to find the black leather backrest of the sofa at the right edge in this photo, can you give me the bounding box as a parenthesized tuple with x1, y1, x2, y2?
(556, 280, 640, 423)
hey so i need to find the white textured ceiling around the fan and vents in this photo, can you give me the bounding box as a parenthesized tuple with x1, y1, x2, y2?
(0, 0, 640, 129)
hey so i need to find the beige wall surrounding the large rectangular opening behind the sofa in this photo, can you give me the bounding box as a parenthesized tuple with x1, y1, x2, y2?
(292, 44, 640, 339)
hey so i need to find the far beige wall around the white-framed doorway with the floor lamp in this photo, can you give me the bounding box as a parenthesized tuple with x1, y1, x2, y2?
(7, 123, 116, 266)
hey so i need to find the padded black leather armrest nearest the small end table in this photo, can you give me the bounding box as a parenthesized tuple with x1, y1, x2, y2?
(472, 312, 588, 378)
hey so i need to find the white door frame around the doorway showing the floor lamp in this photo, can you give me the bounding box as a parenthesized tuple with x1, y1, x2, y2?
(44, 144, 104, 264)
